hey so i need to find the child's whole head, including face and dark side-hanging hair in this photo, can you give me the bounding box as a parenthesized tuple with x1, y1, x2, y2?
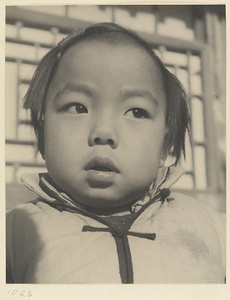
(25, 23, 189, 207)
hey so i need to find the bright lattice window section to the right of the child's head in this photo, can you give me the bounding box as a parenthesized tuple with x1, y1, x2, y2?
(157, 46, 207, 190)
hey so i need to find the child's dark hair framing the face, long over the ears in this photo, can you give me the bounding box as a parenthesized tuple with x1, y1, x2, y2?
(23, 22, 190, 165)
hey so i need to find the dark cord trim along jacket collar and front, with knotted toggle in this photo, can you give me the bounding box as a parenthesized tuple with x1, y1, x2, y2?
(41, 183, 170, 283)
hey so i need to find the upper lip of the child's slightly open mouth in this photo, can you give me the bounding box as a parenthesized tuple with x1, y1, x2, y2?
(85, 156, 120, 173)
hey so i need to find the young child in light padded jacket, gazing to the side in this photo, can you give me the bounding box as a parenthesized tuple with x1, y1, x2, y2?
(7, 23, 225, 283)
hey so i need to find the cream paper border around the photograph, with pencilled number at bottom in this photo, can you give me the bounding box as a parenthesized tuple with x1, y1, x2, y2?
(0, 0, 230, 300)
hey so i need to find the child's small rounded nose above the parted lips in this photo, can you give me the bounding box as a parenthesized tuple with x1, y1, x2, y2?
(89, 119, 118, 149)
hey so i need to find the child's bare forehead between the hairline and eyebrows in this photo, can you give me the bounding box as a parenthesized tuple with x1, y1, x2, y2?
(47, 39, 164, 103)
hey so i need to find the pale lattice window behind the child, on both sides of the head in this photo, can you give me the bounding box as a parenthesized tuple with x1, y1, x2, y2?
(6, 8, 218, 197)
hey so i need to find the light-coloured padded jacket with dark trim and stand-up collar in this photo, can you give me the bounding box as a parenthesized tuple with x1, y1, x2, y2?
(6, 168, 225, 284)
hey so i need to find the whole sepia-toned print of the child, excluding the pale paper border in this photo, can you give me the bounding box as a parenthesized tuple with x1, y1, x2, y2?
(5, 4, 227, 285)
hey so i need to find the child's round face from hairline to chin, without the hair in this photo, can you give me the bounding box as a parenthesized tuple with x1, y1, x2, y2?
(44, 42, 166, 207)
